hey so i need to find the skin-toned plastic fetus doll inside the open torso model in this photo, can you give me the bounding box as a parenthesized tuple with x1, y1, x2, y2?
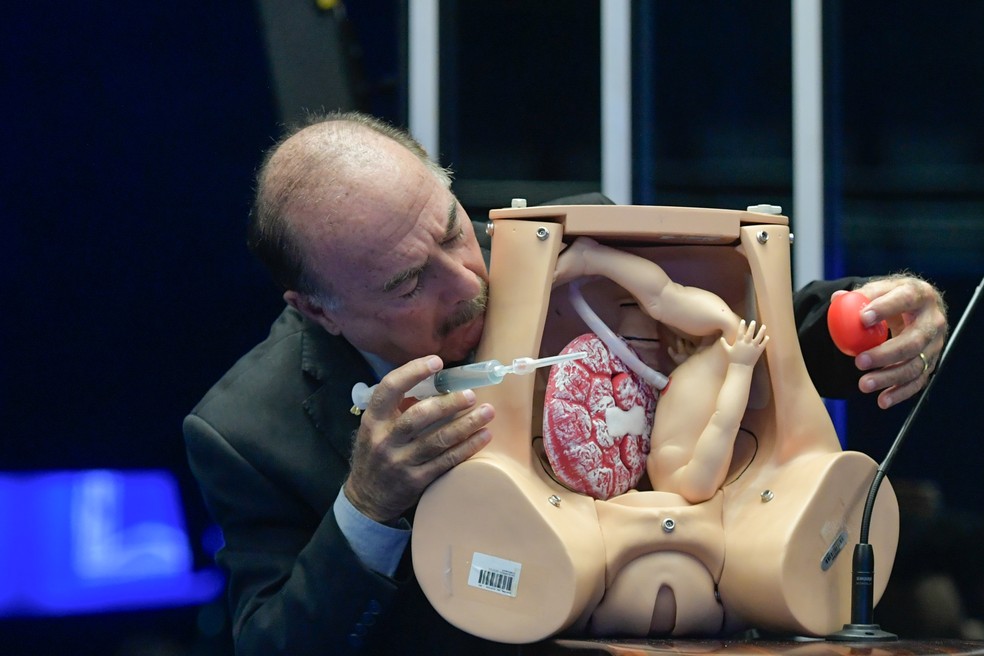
(555, 238, 768, 503)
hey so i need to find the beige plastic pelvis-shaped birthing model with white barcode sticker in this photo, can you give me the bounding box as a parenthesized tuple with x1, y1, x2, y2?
(412, 206, 898, 643)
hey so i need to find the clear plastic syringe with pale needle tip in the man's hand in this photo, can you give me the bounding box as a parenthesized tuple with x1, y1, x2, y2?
(352, 351, 588, 411)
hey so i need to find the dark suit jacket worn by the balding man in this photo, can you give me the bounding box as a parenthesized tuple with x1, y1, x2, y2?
(184, 258, 857, 656)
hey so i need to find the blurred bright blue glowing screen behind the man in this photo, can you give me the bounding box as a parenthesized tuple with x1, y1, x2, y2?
(0, 470, 224, 616)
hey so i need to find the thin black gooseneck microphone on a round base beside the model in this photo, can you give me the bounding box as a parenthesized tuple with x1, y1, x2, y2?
(827, 279, 984, 642)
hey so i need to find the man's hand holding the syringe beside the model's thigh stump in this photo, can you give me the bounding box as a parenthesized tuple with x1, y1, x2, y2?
(345, 356, 495, 523)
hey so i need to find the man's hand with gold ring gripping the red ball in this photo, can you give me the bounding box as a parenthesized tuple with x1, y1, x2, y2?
(835, 275, 947, 408)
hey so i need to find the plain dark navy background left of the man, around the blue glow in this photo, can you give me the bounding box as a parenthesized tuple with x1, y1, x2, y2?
(0, 5, 280, 654)
